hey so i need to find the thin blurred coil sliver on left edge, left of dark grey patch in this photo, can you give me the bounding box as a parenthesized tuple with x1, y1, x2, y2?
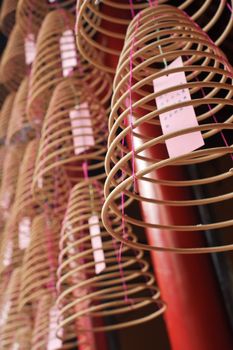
(0, 92, 15, 143)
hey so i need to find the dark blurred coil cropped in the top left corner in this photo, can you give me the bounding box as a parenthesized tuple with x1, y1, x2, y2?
(0, 0, 18, 36)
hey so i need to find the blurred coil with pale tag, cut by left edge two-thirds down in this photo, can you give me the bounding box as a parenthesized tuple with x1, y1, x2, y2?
(0, 217, 24, 273)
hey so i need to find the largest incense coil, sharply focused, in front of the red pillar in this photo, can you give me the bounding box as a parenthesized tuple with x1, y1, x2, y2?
(102, 5, 233, 253)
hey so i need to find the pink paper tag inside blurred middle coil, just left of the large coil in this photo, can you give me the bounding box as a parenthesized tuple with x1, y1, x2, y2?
(70, 102, 95, 155)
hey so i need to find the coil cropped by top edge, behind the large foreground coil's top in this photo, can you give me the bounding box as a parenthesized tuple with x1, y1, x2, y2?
(76, 0, 233, 74)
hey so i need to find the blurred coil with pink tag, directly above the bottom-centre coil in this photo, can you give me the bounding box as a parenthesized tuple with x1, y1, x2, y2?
(34, 78, 107, 193)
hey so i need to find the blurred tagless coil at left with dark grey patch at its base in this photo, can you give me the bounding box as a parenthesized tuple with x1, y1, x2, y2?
(7, 77, 35, 143)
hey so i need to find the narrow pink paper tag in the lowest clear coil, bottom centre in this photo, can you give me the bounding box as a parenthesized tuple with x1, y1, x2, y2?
(88, 215, 106, 274)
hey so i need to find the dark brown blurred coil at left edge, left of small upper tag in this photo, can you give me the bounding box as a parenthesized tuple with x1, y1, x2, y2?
(0, 25, 26, 91)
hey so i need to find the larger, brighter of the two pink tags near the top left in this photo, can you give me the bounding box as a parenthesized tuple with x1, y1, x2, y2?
(60, 29, 78, 77)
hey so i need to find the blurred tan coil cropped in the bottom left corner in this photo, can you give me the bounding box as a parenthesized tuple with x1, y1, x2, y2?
(0, 269, 32, 350)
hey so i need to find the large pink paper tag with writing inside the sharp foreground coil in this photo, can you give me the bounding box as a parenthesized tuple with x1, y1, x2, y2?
(153, 57, 204, 158)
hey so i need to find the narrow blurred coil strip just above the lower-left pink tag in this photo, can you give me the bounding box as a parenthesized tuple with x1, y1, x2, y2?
(13, 140, 42, 221)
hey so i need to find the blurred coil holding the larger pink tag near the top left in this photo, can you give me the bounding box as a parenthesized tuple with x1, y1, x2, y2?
(27, 10, 111, 128)
